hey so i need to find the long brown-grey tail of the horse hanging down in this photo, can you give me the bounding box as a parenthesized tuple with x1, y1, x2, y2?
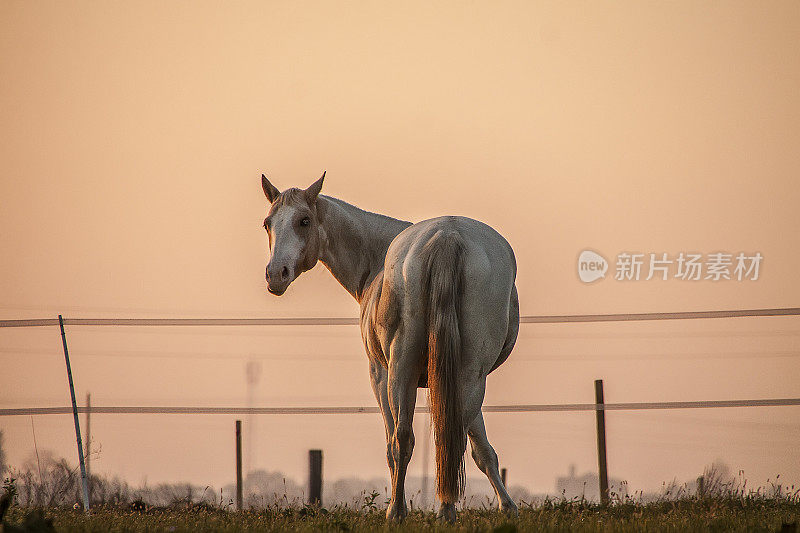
(422, 230, 467, 503)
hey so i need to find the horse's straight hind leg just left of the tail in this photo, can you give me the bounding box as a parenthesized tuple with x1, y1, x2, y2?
(386, 335, 421, 520)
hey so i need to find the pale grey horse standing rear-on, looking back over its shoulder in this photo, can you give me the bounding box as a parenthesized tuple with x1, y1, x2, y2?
(261, 172, 519, 522)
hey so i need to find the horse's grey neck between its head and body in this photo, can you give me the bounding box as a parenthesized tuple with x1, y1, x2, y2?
(317, 195, 411, 303)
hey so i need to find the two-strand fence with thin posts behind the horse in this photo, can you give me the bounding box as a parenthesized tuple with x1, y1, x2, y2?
(0, 307, 800, 512)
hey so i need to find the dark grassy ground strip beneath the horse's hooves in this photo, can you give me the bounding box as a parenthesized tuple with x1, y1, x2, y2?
(5, 498, 800, 533)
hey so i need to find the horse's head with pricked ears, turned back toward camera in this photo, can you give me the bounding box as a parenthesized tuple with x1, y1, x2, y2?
(261, 172, 325, 296)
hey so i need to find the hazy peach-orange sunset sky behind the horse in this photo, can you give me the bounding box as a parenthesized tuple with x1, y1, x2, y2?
(0, 1, 800, 498)
